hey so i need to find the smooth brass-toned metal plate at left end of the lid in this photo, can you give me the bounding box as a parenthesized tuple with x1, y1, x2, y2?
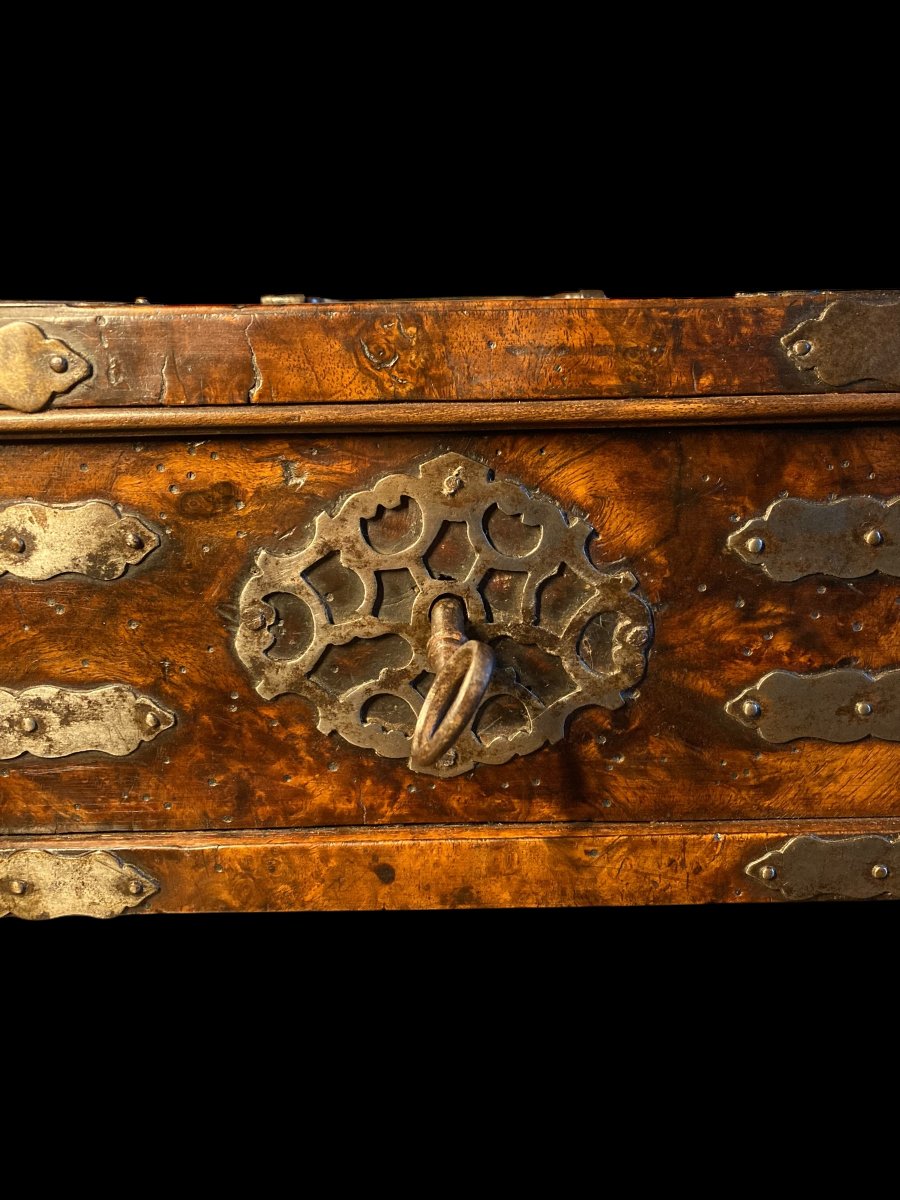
(0, 320, 91, 413)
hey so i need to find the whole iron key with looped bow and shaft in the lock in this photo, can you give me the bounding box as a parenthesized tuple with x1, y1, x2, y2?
(412, 596, 494, 767)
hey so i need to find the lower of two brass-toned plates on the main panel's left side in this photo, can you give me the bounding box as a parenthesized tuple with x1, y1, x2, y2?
(0, 683, 175, 758)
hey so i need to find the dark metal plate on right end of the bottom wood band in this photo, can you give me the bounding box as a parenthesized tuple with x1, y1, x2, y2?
(744, 834, 900, 900)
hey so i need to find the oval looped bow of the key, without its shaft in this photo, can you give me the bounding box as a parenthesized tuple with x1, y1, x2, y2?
(412, 642, 494, 767)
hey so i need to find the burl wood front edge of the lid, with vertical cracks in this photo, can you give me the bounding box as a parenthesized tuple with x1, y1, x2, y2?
(0, 293, 887, 410)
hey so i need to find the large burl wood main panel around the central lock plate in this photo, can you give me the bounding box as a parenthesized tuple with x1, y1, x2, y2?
(0, 426, 900, 833)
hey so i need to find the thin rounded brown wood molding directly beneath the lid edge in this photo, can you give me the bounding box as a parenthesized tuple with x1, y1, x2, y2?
(0, 392, 900, 440)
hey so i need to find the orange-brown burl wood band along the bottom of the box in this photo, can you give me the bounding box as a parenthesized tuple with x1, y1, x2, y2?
(0, 818, 900, 913)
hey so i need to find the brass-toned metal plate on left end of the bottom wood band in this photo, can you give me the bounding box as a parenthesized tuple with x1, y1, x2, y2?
(0, 850, 160, 920)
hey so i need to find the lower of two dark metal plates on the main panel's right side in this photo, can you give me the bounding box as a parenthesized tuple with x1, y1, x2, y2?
(725, 668, 900, 742)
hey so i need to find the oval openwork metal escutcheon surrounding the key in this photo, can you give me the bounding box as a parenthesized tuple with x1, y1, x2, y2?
(235, 454, 650, 776)
